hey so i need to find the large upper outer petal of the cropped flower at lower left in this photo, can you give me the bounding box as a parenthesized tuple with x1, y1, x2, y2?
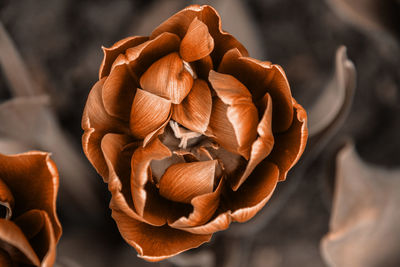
(0, 151, 61, 240)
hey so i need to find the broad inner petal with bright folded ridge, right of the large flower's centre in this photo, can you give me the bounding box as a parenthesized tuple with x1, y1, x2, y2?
(209, 71, 258, 159)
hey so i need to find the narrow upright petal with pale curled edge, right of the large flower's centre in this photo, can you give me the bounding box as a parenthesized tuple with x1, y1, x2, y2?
(231, 94, 274, 191)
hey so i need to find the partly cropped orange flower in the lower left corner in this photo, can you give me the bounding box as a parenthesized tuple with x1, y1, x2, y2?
(0, 151, 61, 267)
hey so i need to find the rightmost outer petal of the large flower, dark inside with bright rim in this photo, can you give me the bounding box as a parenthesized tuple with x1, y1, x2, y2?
(268, 99, 308, 181)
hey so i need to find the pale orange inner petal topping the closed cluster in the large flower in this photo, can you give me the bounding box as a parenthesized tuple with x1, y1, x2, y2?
(140, 53, 193, 104)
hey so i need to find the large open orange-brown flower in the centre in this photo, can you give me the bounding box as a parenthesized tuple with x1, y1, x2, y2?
(82, 5, 307, 261)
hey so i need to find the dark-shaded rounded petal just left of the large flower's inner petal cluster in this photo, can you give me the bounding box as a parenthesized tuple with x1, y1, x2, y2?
(102, 64, 138, 121)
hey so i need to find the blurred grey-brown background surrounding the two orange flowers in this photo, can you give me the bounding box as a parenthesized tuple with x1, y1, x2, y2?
(0, 0, 400, 267)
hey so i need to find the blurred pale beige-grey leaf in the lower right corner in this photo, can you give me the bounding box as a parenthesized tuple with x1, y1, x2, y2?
(321, 144, 400, 267)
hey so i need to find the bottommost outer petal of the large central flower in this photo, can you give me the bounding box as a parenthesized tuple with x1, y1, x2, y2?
(112, 210, 211, 261)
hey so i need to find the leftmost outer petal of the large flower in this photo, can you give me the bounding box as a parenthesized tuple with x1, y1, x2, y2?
(82, 78, 129, 181)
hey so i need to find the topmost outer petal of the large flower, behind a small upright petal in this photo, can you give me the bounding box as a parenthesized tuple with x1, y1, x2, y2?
(150, 5, 248, 66)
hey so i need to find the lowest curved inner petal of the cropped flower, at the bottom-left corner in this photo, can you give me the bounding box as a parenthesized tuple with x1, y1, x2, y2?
(0, 219, 40, 266)
